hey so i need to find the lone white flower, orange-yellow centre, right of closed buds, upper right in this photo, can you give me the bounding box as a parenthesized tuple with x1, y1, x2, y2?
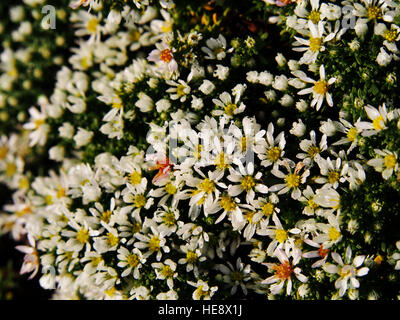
(292, 65, 336, 111)
